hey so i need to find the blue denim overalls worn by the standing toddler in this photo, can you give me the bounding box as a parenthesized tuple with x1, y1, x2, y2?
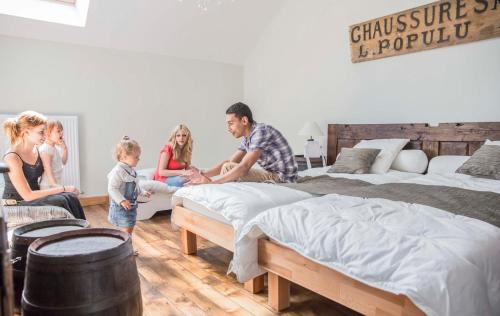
(108, 169, 137, 227)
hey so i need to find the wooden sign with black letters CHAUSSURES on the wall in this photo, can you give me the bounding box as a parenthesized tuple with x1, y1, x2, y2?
(349, 0, 500, 63)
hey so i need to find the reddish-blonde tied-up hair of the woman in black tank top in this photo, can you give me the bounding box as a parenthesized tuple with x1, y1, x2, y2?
(3, 111, 47, 145)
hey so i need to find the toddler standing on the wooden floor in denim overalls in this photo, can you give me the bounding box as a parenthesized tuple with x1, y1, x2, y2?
(108, 136, 150, 239)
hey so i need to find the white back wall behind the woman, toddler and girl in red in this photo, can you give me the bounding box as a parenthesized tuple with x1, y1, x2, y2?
(0, 36, 243, 195)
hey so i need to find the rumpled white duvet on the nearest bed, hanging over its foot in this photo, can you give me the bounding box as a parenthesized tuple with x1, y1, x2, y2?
(235, 194, 500, 316)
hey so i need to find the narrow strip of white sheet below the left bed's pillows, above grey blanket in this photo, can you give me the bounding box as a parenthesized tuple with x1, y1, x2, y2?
(299, 166, 422, 184)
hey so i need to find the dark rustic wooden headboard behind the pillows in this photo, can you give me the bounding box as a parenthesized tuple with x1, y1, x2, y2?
(327, 122, 500, 164)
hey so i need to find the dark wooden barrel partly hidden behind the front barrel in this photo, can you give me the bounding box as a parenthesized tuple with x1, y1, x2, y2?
(11, 219, 90, 306)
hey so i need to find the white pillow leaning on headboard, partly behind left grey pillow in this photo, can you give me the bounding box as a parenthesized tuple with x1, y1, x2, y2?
(354, 138, 410, 174)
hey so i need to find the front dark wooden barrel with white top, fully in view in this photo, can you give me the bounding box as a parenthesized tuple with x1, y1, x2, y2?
(22, 228, 142, 316)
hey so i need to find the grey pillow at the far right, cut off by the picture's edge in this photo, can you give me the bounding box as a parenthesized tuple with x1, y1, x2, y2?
(457, 145, 500, 180)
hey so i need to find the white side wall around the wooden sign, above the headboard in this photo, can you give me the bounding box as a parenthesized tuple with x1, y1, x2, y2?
(244, 0, 500, 152)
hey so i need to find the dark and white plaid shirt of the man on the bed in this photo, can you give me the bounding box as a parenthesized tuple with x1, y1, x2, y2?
(238, 123, 297, 182)
